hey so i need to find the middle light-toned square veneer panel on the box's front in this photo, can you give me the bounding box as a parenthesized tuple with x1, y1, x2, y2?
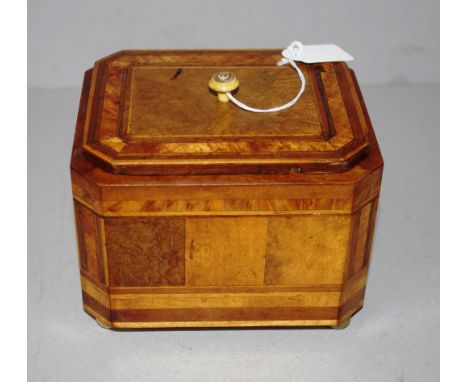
(186, 217, 267, 286)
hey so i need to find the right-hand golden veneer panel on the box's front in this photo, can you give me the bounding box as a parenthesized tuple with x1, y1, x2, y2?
(265, 215, 350, 285)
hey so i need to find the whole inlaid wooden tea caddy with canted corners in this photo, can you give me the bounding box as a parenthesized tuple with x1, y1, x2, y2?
(71, 50, 383, 328)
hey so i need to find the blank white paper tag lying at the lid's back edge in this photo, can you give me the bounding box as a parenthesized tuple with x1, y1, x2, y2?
(282, 41, 353, 64)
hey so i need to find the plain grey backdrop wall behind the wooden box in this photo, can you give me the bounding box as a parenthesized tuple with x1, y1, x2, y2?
(28, 0, 439, 87)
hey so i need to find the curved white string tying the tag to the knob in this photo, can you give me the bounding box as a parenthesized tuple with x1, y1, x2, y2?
(226, 41, 306, 113)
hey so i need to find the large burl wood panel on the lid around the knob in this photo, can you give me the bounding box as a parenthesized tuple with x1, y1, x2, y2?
(127, 66, 322, 141)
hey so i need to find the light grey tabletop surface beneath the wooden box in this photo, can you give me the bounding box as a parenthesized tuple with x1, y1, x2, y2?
(28, 86, 439, 382)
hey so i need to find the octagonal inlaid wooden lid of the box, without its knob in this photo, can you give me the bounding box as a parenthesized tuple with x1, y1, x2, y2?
(83, 50, 369, 175)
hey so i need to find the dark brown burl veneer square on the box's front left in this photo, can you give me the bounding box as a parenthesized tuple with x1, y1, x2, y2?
(105, 217, 185, 286)
